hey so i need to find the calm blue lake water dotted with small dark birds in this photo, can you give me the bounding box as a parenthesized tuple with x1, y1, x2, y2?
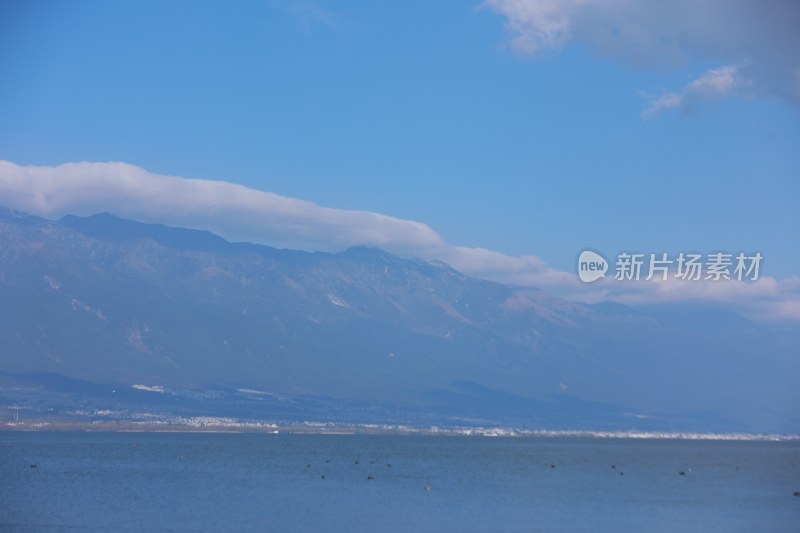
(0, 432, 800, 531)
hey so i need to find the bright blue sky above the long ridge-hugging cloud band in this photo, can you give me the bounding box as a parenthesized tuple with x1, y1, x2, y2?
(0, 0, 800, 316)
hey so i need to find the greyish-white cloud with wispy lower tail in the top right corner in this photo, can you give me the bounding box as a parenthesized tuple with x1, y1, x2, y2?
(483, 0, 800, 114)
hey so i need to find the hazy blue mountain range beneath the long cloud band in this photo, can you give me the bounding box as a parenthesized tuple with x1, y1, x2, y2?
(0, 209, 800, 432)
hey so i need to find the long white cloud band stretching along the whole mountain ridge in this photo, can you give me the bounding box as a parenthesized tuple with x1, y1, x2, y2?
(0, 161, 800, 322)
